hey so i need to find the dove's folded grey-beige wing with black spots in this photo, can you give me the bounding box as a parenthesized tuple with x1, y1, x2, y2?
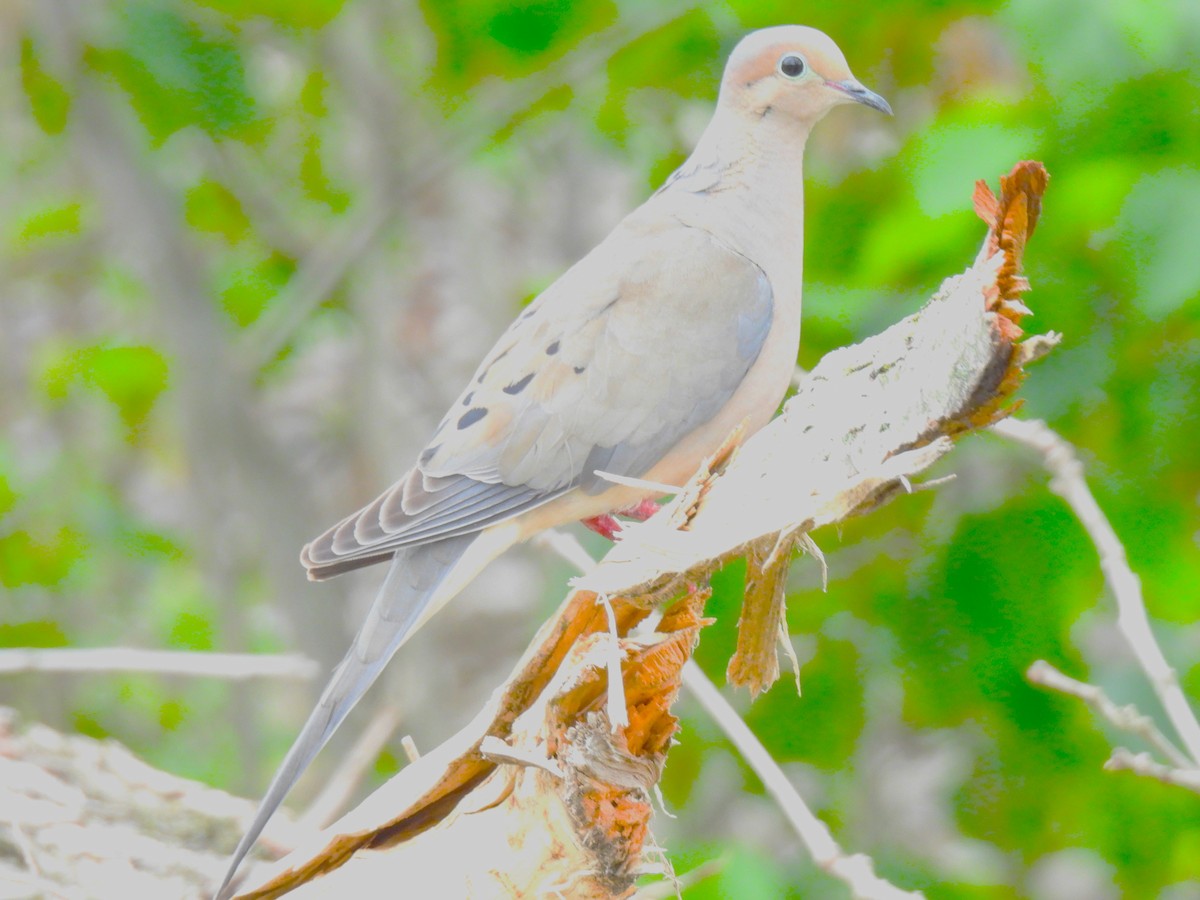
(301, 220, 773, 578)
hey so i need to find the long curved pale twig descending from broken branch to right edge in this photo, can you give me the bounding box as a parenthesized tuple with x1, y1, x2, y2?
(991, 419, 1200, 768)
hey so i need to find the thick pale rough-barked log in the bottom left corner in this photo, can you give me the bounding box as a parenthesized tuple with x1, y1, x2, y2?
(0, 707, 313, 898)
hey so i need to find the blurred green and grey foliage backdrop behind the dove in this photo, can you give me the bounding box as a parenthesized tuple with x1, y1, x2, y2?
(0, 0, 1200, 900)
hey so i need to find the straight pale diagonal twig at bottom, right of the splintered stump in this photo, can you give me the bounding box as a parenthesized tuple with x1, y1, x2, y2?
(683, 660, 924, 900)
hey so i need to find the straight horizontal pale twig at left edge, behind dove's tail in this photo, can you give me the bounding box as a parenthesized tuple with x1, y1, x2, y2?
(0, 647, 317, 682)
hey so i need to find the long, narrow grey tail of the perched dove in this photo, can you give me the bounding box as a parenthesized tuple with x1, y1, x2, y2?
(216, 529, 514, 900)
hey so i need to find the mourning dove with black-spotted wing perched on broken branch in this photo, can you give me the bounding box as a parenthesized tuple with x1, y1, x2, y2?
(218, 25, 892, 896)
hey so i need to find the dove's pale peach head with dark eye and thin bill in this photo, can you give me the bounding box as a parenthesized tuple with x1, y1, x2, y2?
(720, 25, 892, 126)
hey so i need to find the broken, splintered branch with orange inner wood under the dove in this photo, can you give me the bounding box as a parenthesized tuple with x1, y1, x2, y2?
(231, 162, 1056, 898)
